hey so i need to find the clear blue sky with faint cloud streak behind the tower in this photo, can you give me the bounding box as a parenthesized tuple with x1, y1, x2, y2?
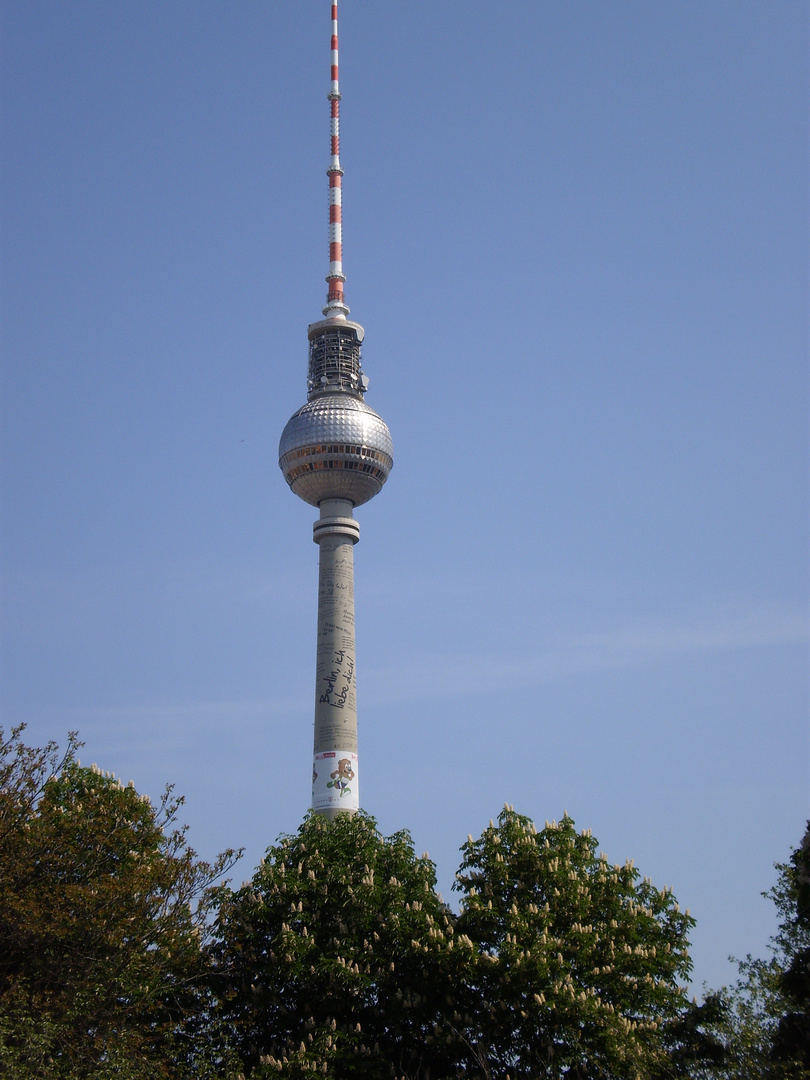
(1, 0, 810, 991)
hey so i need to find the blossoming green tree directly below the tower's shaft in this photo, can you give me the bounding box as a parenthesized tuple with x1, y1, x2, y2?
(214, 813, 473, 1080)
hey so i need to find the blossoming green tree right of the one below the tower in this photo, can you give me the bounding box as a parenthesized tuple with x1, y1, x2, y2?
(456, 808, 694, 1080)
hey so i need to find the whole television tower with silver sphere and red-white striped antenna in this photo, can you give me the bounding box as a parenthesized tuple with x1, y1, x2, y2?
(279, 0, 393, 819)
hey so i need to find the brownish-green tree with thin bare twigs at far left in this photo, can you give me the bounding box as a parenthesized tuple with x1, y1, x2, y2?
(0, 728, 234, 1080)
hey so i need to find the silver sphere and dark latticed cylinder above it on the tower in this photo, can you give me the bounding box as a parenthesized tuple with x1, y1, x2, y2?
(279, 319, 394, 507)
